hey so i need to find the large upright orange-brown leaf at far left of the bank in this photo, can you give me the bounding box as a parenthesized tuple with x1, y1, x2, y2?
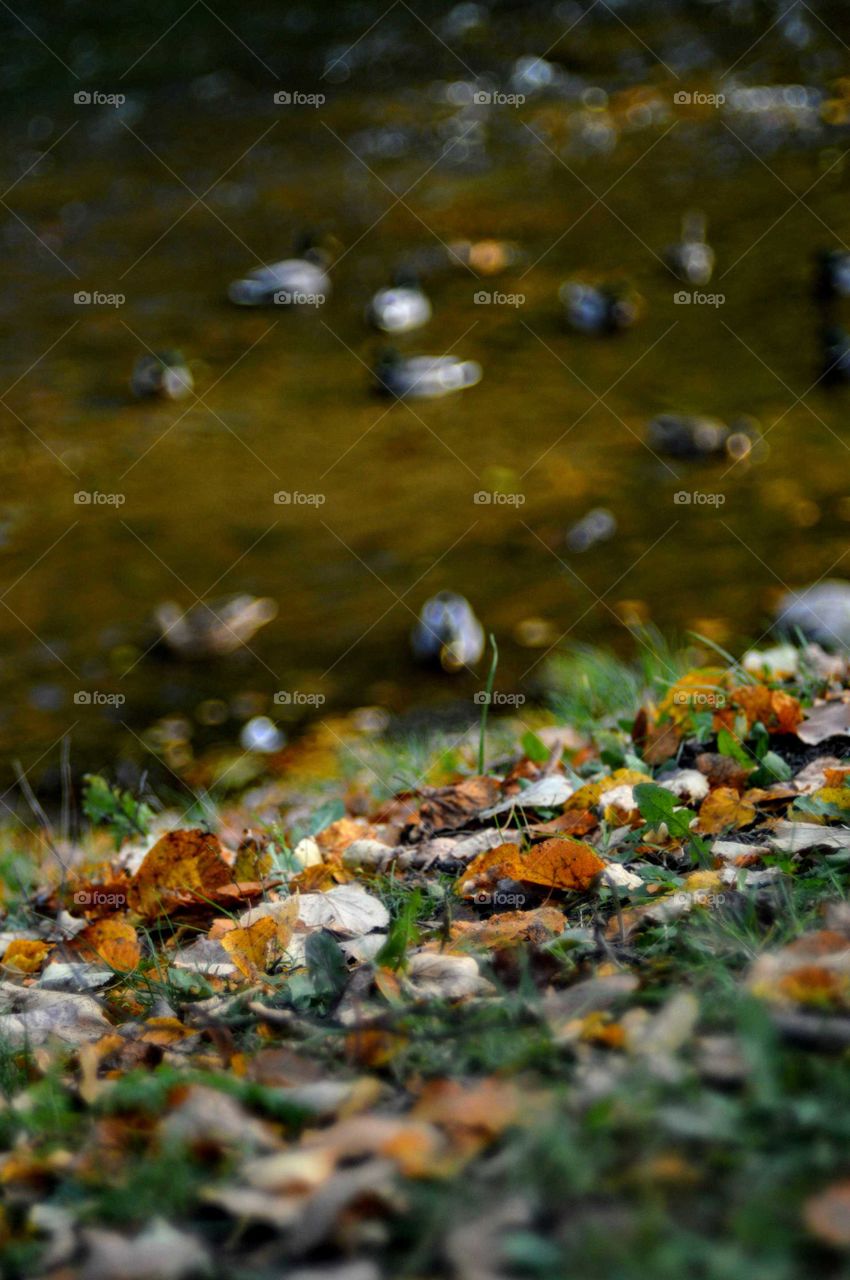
(127, 829, 233, 916)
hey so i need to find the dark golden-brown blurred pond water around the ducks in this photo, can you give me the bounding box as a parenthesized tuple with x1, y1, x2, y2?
(0, 0, 850, 778)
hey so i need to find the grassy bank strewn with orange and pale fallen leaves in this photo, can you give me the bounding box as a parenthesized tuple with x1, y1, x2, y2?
(0, 646, 850, 1280)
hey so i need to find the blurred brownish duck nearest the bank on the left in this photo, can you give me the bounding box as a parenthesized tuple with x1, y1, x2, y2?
(154, 594, 278, 659)
